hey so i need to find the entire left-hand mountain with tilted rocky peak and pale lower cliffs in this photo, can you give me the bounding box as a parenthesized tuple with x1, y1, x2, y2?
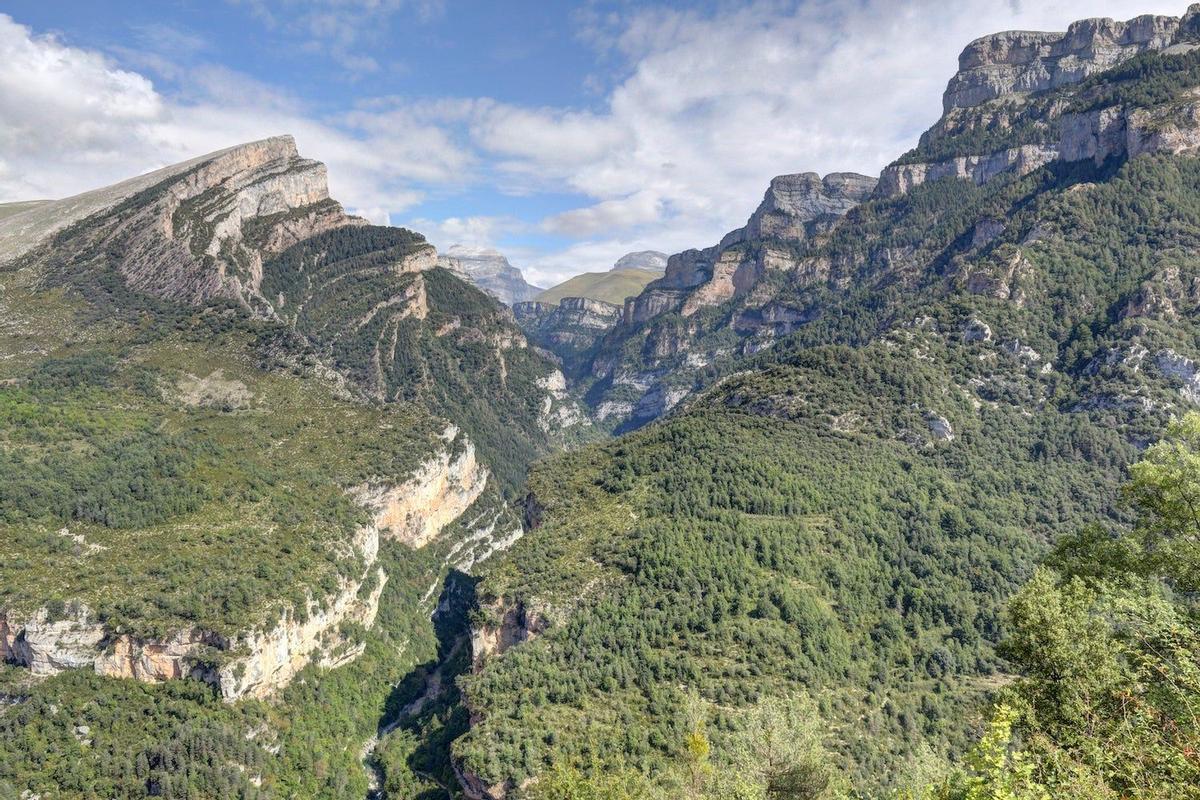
(0, 137, 578, 796)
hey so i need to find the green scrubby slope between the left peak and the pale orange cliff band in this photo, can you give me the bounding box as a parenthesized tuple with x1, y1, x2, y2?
(0, 335, 440, 636)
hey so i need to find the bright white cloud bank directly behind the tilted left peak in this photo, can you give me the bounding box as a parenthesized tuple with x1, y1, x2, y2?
(0, 14, 473, 212)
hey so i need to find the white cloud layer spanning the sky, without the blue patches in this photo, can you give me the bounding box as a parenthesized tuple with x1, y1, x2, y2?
(0, 0, 1182, 283)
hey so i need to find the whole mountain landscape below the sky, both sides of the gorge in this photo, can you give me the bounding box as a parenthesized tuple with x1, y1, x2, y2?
(0, 6, 1200, 800)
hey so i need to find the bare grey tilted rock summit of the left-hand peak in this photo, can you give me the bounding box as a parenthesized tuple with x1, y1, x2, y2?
(14, 136, 366, 304)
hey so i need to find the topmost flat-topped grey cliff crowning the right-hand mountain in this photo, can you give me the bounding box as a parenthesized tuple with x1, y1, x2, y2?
(942, 6, 1200, 112)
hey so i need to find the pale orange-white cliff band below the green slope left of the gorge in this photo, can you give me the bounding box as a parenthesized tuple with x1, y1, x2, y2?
(0, 426, 487, 700)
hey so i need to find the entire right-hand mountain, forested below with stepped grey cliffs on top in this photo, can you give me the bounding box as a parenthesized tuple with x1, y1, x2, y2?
(412, 7, 1200, 798)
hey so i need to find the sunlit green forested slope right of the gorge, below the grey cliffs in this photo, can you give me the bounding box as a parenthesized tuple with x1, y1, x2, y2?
(455, 347, 1132, 789)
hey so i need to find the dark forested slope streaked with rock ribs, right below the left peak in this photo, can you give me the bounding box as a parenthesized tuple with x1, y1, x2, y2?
(263, 225, 566, 492)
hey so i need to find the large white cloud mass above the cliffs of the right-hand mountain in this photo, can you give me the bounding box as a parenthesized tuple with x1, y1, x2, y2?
(474, 0, 1180, 286)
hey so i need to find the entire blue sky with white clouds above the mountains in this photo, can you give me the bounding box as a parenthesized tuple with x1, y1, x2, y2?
(0, 0, 1186, 285)
